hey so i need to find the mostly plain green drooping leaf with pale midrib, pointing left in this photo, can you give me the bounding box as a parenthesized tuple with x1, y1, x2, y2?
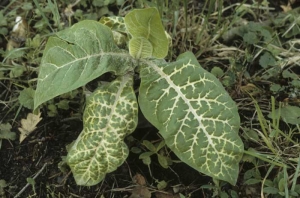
(34, 20, 132, 108)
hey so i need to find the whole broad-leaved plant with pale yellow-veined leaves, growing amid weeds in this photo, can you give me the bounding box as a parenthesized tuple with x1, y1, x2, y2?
(34, 8, 243, 186)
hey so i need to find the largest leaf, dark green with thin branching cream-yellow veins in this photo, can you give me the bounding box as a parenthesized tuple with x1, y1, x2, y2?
(139, 52, 243, 184)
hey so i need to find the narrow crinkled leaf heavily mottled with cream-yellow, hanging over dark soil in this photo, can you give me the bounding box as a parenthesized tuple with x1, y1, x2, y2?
(67, 75, 138, 186)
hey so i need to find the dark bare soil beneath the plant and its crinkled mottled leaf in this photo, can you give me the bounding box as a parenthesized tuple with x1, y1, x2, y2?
(0, 110, 211, 198)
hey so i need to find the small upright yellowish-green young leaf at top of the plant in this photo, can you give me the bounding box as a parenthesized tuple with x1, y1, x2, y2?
(125, 8, 169, 58)
